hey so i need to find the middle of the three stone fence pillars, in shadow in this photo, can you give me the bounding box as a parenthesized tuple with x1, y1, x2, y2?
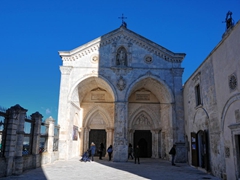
(31, 112, 43, 168)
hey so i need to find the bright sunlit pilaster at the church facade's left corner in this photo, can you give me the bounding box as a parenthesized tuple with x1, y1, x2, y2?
(58, 66, 72, 160)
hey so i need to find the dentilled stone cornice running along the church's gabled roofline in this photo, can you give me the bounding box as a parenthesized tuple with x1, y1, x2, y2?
(59, 28, 186, 63)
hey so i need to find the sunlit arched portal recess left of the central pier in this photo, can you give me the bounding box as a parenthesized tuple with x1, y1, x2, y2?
(77, 77, 115, 155)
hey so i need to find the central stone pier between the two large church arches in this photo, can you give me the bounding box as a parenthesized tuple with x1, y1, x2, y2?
(113, 102, 128, 162)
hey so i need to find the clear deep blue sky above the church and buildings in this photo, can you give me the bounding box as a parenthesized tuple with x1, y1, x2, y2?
(0, 0, 240, 120)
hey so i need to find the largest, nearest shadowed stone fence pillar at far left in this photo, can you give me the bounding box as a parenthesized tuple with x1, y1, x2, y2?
(4, 105, 27, 176)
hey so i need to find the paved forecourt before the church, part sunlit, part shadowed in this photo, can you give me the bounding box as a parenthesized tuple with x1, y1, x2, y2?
(0, 157, 219, 180)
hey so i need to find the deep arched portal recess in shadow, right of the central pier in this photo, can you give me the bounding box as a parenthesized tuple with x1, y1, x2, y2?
(128, 75, 175, 158)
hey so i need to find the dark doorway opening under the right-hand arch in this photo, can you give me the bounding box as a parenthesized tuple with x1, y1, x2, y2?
(134, 130, 152, 158)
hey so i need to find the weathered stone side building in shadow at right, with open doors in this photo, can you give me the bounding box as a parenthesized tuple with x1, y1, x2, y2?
(184, 21, 240, 179)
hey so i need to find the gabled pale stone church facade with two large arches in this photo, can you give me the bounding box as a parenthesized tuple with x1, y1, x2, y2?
(58, 24, 187, 162)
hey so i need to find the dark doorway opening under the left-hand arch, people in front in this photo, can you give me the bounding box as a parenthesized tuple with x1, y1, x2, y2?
(88, 129, 106, 156)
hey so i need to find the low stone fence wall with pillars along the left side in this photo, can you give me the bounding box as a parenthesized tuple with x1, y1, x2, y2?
(0, 105, 59, 177)
